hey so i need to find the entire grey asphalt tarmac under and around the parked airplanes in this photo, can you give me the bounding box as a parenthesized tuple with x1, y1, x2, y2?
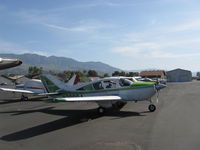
(0, 81, 200, 150)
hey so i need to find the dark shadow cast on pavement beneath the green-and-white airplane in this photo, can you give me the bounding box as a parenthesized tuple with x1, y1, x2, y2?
(0, 107, 144, 141)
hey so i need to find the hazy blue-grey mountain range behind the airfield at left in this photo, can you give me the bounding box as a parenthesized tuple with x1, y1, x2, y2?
(0, 53, 121, 74)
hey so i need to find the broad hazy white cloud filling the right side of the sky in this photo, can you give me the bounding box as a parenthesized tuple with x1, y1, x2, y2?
(111, 12, 200, 59)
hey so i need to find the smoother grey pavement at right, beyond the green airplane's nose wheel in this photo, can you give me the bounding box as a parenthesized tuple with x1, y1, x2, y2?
(148, 82, 200, 150)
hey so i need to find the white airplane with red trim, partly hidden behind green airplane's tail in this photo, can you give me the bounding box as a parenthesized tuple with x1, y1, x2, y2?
(0, 75, 77, 100)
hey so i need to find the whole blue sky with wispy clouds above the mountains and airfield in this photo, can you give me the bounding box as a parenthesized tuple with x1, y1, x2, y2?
(0, 0, 200, 71)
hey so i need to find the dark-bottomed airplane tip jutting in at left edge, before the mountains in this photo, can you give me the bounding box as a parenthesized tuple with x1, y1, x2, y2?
(0, 58, 22, 70)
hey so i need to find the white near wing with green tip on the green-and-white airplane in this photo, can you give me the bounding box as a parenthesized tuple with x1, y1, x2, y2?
(54, 96, 122, 102)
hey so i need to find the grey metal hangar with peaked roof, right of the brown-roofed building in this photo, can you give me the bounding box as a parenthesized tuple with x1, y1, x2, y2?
(167, 68, 192, 82)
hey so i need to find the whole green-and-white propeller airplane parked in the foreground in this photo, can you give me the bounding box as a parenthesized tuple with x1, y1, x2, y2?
(41, 74, 166, 113)
